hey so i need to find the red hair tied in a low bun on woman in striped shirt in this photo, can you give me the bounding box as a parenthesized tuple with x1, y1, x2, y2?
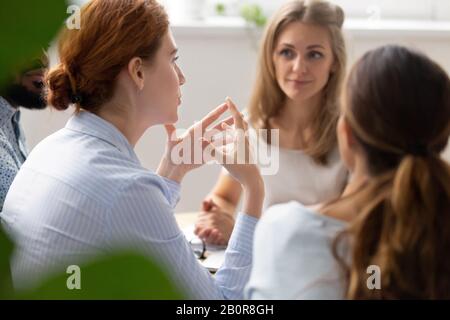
(46, 0, 169, 112)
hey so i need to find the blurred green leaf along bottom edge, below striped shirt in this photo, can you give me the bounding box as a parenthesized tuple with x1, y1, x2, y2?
(17, 253, 185, 300)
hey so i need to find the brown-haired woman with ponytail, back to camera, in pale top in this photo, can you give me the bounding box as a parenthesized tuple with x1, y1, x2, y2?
(247, 46, 450, 299)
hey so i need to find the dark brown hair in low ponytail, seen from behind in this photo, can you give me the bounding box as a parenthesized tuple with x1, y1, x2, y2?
(334, 46, 450, 299)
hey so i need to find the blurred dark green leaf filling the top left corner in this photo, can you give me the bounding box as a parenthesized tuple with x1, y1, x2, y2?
(0, 0, 69, 88)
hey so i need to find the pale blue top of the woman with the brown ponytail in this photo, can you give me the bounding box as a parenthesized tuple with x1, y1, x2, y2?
(245, 201, 345, 300)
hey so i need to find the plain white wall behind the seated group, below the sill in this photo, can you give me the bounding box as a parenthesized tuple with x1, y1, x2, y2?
(19, 21, 450, 211)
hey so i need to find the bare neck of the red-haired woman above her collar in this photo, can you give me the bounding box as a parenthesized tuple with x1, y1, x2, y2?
(96, 102, 146, 148)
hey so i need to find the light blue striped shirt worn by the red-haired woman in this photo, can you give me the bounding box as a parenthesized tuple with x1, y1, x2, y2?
(1, 112, 257, 299)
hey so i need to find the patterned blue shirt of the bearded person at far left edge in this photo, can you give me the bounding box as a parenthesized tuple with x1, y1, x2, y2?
(0, 97, 28, 211)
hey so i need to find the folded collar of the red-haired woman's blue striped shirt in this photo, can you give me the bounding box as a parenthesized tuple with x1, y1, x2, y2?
(65, 111, 140, 163)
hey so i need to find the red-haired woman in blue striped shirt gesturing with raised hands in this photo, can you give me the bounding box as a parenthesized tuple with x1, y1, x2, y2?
(1, 0, 264, 299)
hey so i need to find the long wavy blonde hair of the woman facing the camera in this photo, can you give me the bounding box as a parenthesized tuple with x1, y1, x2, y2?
(248, 0, 347, 165)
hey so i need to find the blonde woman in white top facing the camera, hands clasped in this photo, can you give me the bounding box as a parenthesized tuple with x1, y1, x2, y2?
(195, 1, 347, 244)
